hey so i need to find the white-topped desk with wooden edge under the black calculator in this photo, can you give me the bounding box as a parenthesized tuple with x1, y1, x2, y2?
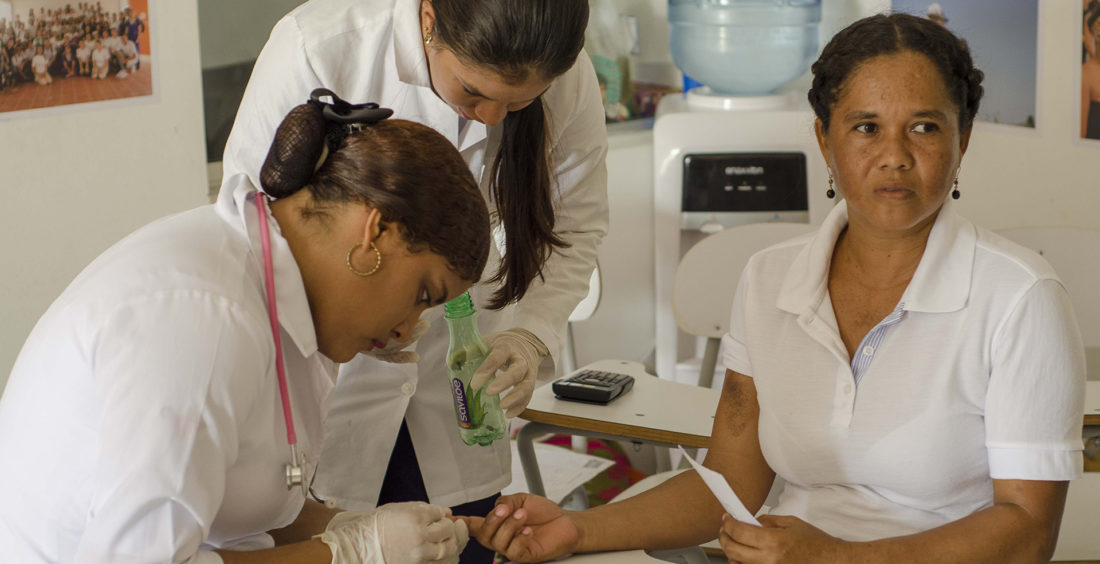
(516, 360, 721, 496)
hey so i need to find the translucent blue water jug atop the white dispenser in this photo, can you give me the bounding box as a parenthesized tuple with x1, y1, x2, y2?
(669, 0, 822, 96)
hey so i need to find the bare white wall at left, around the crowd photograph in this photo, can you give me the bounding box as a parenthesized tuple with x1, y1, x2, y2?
(0, 0, 207, 393)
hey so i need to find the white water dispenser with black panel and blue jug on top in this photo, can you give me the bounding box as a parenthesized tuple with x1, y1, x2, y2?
(653, 0, 832, 383)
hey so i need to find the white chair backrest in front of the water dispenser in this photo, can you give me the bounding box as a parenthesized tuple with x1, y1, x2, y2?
(672, 223, 816, 339)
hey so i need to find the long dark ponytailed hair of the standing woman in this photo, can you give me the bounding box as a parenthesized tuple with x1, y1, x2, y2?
(425, 0, 589, 309)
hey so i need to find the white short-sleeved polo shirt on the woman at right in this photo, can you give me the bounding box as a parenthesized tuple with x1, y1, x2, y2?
(724, 201, 1085, 541)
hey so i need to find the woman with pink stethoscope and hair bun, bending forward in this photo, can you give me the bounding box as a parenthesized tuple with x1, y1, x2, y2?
(0, 90, 490, 564)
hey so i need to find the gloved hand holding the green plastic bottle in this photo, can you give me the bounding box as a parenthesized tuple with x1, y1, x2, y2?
(470, 328, 550, 418)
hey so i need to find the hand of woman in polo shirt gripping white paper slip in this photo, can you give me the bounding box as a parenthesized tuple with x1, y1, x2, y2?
(718, 513, 848, 564)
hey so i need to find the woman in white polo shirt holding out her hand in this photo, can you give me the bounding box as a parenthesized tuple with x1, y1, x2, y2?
(459, 14, 1085, 563)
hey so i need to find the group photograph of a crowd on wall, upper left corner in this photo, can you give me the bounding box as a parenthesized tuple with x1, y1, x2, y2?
(0, 0, 154, 117)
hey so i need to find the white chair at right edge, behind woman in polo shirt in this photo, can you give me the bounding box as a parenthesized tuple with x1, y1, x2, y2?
(998, 223, 1100, 561)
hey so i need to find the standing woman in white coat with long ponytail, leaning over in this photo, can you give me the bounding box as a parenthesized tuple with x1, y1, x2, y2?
(220, 0, 607, 562)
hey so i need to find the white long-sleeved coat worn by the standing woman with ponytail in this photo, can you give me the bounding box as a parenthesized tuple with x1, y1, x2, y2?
(220, 0, 607, 510)
